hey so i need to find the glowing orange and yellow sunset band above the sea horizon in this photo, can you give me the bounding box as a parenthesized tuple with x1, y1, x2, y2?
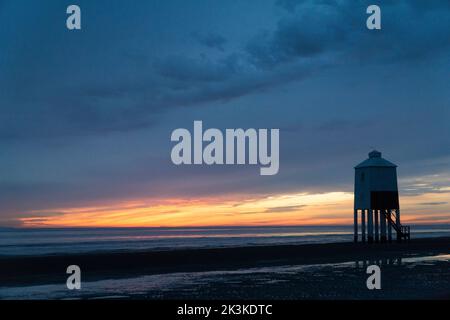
(19, 191, 450, 228)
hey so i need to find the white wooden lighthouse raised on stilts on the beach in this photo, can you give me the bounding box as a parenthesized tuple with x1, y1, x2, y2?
(354, 150, 410, 243)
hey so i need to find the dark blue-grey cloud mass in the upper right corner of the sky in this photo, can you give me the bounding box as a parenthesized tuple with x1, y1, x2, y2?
(248, 0, 450, 65)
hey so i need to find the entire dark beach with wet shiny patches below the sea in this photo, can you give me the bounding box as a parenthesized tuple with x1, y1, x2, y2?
(0, 237, 450, 299)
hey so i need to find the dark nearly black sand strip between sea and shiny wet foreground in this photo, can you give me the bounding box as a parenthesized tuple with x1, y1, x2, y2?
(0, 237, 450, 287)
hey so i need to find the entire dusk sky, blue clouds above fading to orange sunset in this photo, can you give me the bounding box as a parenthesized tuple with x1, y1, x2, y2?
(0, 0, 450, 227)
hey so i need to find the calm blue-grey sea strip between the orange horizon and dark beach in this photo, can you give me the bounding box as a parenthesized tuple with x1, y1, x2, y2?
(0, 225, 450, 255)
